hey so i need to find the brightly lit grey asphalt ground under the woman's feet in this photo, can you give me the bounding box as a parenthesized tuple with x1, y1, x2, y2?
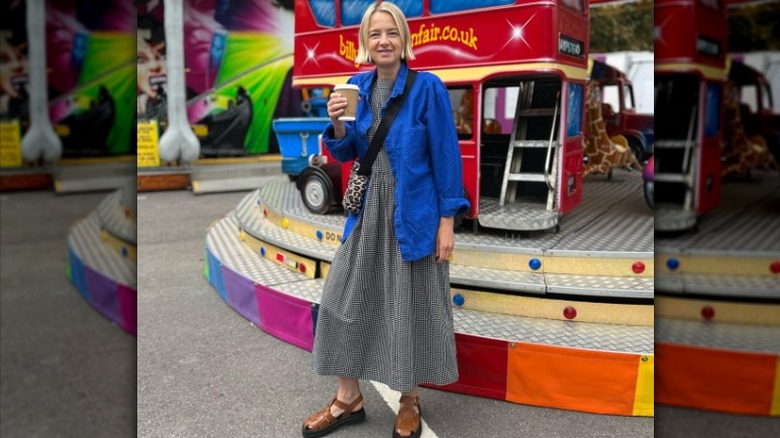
(138, 186, 654, 438)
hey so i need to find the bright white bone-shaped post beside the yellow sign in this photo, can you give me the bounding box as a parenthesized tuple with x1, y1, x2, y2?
(160, 0, 200, 163)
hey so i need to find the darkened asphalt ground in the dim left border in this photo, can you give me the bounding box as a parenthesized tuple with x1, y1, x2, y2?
(0, 191, 136, 438)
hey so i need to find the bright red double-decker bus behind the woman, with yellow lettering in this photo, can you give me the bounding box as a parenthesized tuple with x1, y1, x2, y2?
(293, 0, 589, 231)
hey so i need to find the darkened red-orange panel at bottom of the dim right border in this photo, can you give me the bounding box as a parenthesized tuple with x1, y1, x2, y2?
(655, 343, 777, 415)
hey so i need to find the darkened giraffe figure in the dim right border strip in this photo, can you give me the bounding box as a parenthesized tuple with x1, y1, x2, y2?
(721, 81, 780, 176)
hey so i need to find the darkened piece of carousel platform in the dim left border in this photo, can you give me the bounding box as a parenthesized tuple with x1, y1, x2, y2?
(68, 190, 137, 335)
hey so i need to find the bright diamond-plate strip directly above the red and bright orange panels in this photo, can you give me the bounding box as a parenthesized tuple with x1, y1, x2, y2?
(452, 308, 654, 354)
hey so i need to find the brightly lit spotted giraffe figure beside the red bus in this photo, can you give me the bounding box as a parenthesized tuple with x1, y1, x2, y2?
(582, 81, 642, 176)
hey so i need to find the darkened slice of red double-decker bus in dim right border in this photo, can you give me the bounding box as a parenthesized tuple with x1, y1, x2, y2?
(655, 0, 728, 226)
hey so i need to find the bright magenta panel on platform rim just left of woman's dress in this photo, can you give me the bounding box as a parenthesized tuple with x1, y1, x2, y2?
(255, 284, 314, 351)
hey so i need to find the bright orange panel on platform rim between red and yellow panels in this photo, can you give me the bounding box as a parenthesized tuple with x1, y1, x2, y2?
(507, 343, 641, 415)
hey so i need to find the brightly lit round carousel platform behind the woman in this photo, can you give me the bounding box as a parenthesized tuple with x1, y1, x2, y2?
(205, 169, 654, 416)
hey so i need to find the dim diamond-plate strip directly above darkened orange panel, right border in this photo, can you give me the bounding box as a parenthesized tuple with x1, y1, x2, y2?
(655, 317, 780, 354)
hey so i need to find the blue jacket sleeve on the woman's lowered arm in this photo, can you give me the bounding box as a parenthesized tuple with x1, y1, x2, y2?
(426, 75, 469, 217)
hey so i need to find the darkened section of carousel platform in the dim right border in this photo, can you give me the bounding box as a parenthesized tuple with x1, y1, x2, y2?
(655, 171, 780, 416)
